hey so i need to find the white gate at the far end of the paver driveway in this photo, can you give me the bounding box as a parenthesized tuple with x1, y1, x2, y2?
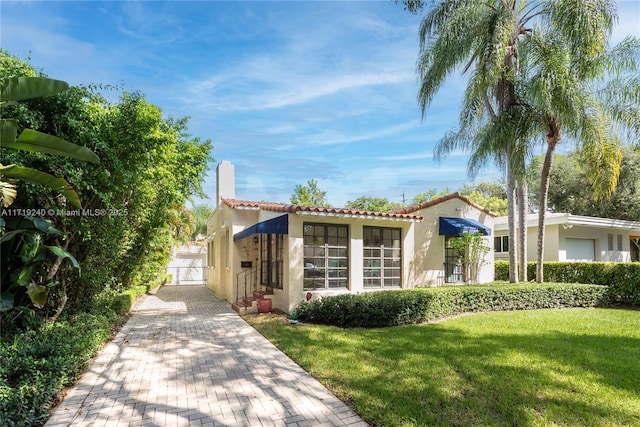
(167, 245, 207, 286)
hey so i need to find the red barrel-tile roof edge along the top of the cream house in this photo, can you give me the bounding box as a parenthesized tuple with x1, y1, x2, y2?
(222, 193, 497, 221)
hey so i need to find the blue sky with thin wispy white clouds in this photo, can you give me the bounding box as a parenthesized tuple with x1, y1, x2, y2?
(0, 0, 640, 206)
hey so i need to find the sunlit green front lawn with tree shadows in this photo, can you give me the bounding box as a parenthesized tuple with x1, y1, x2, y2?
(246, 309, 640, 426)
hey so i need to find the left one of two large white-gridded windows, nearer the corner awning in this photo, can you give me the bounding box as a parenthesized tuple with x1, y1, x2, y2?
(303, 223, 349, 289)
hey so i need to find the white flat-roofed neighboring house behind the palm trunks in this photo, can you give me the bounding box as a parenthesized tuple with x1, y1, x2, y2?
(493, 213, 640, 262)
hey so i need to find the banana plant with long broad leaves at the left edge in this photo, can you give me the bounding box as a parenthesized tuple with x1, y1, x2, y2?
(0, 73, 99, 320)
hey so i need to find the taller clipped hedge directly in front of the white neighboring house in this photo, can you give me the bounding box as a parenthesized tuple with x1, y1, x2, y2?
(495, 261, 640, 305)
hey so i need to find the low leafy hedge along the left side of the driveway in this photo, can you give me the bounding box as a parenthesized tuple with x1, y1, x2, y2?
(0, 286, 157, 426)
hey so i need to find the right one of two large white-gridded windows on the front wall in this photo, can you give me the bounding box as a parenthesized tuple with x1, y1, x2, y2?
(362, 227, 402, 288)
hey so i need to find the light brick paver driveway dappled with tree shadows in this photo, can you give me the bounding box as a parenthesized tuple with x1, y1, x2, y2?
(46, 286, 367, 427)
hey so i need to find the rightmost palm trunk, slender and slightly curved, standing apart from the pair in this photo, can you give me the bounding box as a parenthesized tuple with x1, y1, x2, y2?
(536, 117, 560, 283)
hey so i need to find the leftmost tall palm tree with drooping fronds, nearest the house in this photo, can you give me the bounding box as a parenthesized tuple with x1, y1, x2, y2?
(416, 0, 535, 282)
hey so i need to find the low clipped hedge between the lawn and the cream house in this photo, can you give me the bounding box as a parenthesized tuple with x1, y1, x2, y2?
(296, 283, 610, 328)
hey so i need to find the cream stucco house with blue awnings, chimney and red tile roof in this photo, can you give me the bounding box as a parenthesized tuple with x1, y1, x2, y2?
(207, 161, 495, 312)
